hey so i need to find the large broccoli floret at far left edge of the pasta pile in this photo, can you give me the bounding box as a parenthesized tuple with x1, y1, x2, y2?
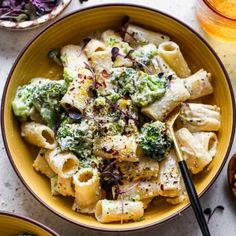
(12, 79, 67, 128)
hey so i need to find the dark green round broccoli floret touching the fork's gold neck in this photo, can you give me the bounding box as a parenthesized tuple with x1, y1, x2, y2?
(139, 121, 172, 162)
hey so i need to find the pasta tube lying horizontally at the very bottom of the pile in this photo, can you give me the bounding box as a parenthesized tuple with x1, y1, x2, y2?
(95, 199, 144, 223)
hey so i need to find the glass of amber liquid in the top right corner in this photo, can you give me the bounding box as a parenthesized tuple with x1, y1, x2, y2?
(197, 0, 236, 41)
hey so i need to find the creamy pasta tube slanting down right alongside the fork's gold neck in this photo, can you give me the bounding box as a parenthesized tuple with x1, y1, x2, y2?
(176, 128, 212, 174)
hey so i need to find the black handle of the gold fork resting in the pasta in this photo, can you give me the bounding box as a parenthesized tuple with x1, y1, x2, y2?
(179, 160, 211, 236)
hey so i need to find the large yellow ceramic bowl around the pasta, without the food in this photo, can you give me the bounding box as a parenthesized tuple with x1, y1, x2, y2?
(2, 5, 234, 231)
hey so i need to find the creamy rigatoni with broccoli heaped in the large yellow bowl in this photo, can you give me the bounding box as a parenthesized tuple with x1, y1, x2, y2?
(12, 20, 221, 223)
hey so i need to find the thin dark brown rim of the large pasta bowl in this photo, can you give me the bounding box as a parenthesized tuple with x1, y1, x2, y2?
(1, 3, 236, 232)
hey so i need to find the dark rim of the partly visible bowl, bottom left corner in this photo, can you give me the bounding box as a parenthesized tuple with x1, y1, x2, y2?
(0, 211, 60, 236)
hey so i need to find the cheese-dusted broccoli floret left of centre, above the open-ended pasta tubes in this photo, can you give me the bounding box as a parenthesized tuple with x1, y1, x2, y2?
(57, 120, 96, 158)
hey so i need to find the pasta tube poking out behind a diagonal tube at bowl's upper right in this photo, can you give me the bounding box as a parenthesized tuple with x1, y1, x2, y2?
(184, 69, 213, 100)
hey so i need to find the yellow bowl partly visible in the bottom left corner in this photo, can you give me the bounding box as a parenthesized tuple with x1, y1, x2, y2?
(0, 211, 59, 236)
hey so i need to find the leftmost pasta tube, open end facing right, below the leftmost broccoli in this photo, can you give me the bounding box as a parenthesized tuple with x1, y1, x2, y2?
(21, 122, 57, 149)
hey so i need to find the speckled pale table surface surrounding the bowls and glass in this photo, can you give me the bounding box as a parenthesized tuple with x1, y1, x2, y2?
(0, 0, 236, 236)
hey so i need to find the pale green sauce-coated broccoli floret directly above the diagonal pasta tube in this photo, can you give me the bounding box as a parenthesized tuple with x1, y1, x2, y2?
(131, 72, 167, 107)
